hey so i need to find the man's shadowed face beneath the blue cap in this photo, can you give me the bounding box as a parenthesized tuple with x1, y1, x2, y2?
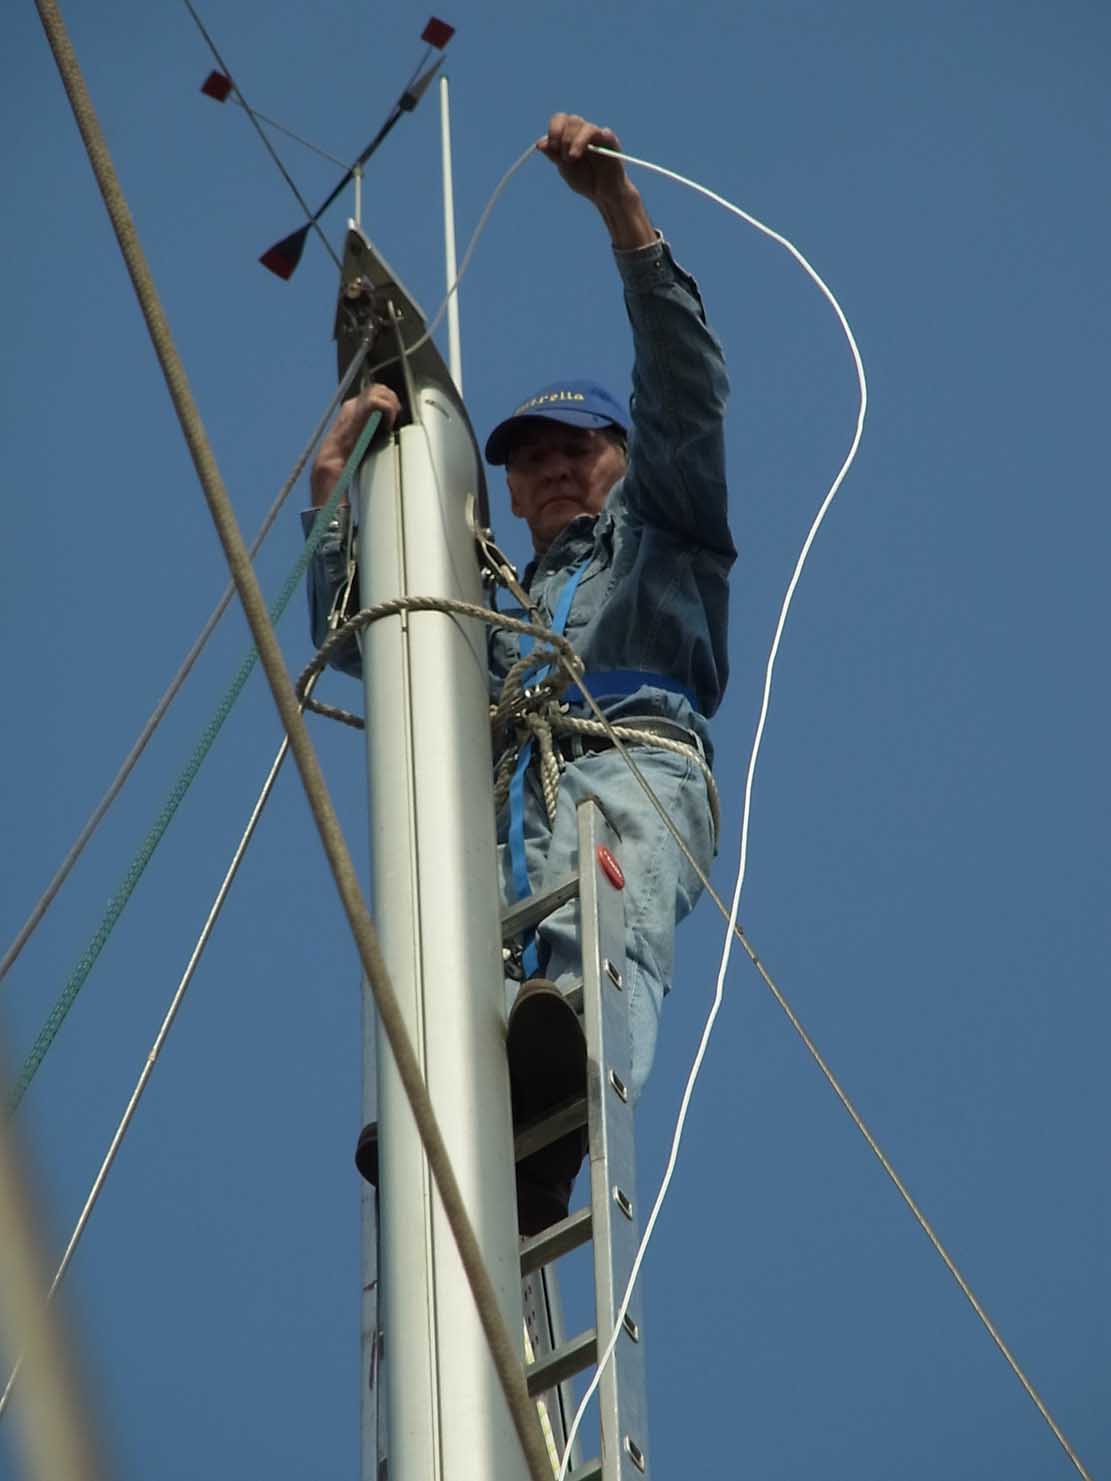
(505, 421, 625, 555)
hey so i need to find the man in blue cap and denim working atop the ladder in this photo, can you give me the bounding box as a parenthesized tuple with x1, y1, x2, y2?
(311, 113, 736, 1234)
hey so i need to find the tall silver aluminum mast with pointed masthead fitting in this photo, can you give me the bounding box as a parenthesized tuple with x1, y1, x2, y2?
(336, 227, 527, 1481)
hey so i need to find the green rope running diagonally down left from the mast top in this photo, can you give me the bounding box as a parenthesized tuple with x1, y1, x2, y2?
(7, 412, 382, 1114)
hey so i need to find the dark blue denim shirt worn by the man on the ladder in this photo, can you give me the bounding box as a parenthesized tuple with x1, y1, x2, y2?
(302, 238, 736, 757)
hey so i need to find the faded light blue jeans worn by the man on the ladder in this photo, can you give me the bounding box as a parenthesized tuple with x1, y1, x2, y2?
(498, 745, 714, 1100)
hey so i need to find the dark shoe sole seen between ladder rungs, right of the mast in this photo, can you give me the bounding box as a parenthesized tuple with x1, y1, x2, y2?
(507, 977, 587, 1235)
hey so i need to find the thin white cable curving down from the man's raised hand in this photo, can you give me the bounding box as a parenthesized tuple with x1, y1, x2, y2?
(558, 145, 868, 1481)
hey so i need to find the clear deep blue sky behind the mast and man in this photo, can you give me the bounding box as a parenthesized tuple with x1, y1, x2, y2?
(0, 0, 1111, 1481)
